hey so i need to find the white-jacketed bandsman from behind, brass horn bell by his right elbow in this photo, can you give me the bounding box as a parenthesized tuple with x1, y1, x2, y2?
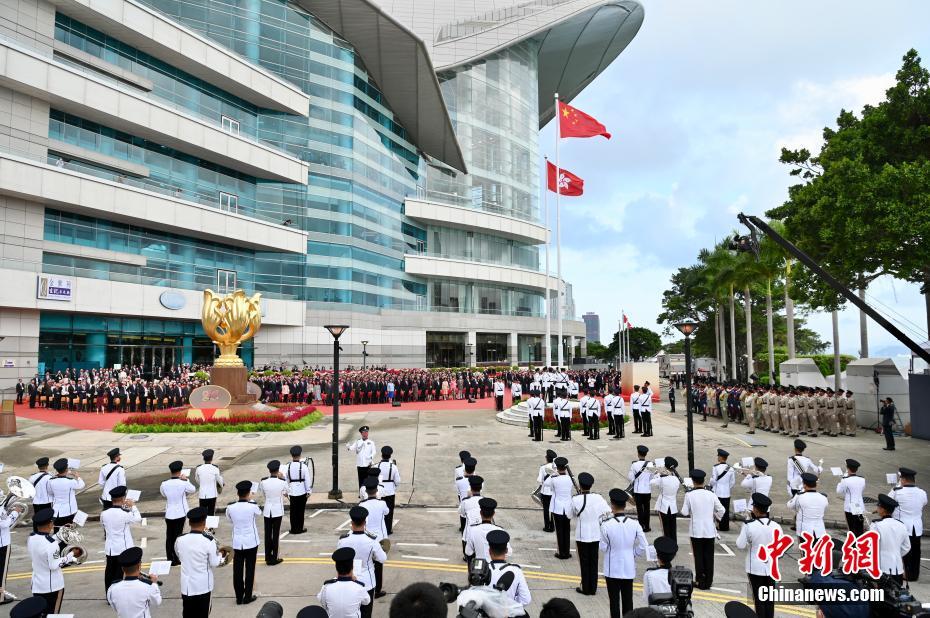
(171, 506, 221, 618)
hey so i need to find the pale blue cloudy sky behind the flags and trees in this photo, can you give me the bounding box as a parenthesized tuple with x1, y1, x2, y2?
(540, 0, 930, 356)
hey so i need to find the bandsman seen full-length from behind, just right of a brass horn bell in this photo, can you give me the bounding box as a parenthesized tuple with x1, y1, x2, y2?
(226, 481, 260, 605)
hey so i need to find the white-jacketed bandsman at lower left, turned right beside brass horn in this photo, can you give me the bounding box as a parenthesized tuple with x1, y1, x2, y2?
(26, 509, 80, 616)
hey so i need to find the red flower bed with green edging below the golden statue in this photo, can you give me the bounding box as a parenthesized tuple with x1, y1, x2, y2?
(113, 406, 323, 433)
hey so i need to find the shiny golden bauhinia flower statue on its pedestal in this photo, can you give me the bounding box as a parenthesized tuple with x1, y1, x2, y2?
(200, 290, 262, 367)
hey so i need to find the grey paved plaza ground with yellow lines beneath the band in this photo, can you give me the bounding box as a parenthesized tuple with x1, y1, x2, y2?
(0, 397, 930, 617)
